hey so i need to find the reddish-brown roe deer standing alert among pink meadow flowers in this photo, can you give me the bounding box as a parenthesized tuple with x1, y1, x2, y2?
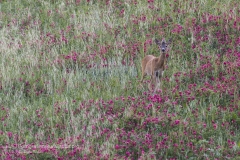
(141, 39, 171, 92)
